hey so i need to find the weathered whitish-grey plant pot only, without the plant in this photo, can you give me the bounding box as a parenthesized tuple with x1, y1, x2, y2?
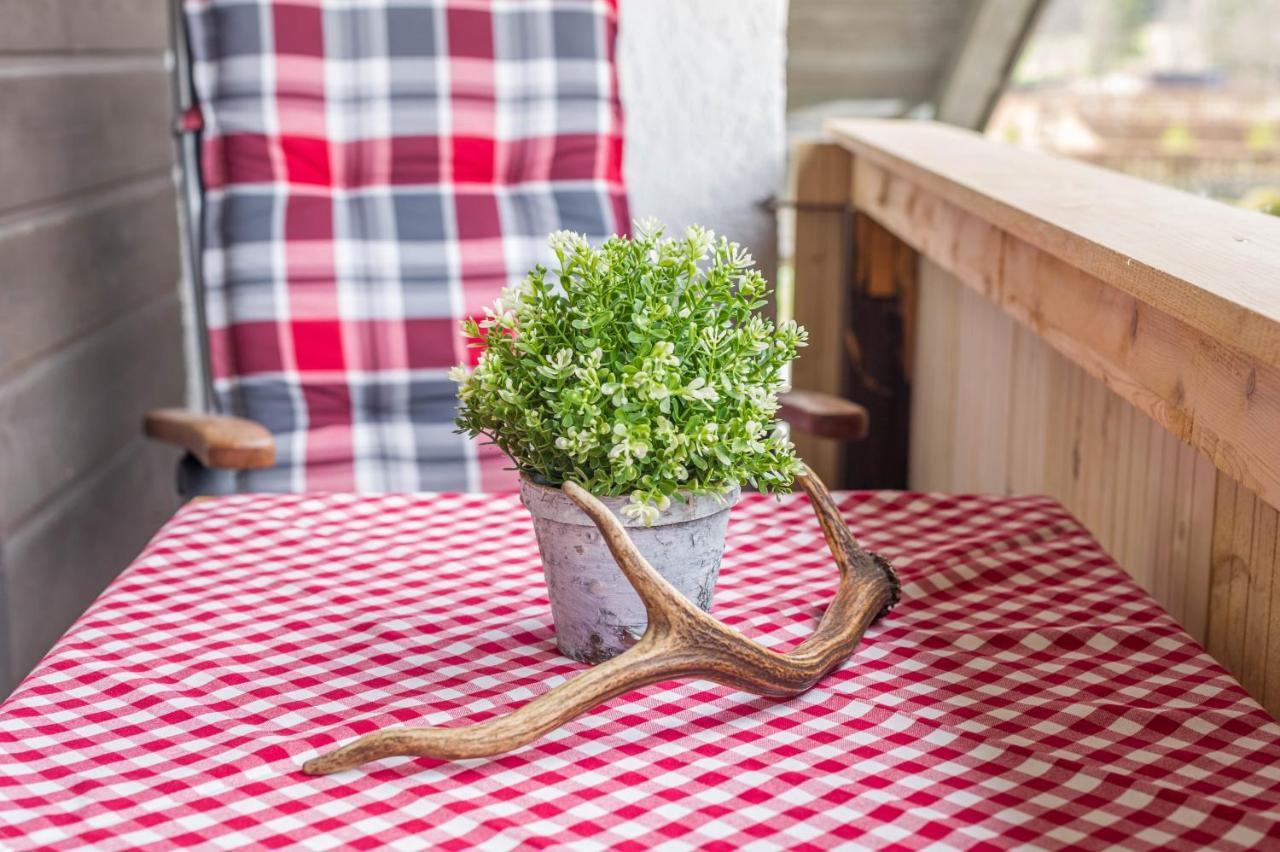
(520, 477, 739, 664)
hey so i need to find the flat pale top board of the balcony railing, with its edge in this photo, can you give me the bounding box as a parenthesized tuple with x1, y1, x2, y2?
(827, 119, 1280, 366)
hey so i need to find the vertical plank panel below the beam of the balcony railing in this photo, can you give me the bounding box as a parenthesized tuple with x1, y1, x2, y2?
(909, 260, 1280, 716)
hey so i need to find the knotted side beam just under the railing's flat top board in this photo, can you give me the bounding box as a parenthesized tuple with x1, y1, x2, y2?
(855, 151, 1280, 504)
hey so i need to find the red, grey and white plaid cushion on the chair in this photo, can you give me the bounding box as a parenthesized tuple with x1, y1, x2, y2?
(184, 0, 628, 491)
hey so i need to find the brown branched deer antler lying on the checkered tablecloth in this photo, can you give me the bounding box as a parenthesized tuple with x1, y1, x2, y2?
(302, 467, 899, 775)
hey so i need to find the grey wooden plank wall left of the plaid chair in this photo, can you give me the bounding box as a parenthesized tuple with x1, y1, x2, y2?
(0, 0, 184, 695)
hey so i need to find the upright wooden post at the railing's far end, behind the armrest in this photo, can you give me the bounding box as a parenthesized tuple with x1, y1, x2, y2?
(787, 143, 852, 486)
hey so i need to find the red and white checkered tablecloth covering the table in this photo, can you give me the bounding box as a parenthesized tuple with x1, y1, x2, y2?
(0, 493, 1280, 849)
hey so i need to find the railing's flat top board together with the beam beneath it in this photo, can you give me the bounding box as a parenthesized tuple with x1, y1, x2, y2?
(827, 120, 1280, 507)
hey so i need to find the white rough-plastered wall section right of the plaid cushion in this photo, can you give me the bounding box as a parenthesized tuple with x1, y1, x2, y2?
(618, 0, 787, 275)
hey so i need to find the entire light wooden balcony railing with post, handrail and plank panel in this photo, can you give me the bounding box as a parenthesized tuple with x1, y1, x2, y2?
(792, 120, 1280, 713)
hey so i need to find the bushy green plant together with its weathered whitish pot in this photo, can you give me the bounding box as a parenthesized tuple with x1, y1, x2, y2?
(451, 224, 805, 663)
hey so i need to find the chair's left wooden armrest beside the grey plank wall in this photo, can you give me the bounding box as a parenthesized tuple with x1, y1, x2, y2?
(143, 408, 275, 471)
